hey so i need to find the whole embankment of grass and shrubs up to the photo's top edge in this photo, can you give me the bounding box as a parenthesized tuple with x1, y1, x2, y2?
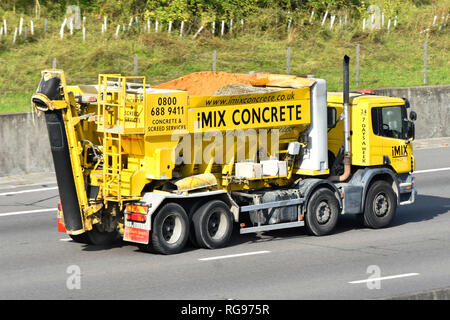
(0, 0, 450, 112)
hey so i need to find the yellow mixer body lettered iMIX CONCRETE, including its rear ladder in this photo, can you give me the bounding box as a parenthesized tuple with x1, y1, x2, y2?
(67, 75, 320, 205)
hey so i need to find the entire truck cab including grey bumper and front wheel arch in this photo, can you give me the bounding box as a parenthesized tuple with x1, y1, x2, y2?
(327, 92, 417, 219)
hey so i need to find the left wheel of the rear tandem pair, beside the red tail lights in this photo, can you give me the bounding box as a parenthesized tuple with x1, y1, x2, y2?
(149, 203, 189, 254)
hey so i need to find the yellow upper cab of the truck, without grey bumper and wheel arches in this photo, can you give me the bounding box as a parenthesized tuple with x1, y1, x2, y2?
(328, 92, 415, 174)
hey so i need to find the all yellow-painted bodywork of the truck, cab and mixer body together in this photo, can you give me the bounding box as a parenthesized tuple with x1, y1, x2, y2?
(44, 71, 413, 225)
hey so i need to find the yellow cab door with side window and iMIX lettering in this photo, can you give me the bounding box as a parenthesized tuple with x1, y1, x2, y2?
(372, 105, 412, 173)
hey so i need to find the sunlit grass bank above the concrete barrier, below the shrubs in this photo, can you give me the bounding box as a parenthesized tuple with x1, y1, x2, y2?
(0, 0, 450, 112)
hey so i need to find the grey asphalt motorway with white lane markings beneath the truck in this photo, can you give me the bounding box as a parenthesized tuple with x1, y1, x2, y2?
(0, 147, 450, 299)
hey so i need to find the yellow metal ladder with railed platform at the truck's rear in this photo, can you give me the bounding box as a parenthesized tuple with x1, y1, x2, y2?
(97, 74, 145, 209)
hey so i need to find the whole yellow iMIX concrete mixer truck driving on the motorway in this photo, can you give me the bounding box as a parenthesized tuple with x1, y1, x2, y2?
(32, 56, 416, 254)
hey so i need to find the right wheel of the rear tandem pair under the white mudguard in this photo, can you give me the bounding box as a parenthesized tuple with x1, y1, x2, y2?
(192, 200, 233, 249)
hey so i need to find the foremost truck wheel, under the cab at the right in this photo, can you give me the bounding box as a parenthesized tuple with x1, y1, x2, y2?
(363, 180, 397, 229)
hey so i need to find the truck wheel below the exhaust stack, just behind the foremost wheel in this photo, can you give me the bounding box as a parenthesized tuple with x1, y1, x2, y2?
(305, 188, 339, 236)
